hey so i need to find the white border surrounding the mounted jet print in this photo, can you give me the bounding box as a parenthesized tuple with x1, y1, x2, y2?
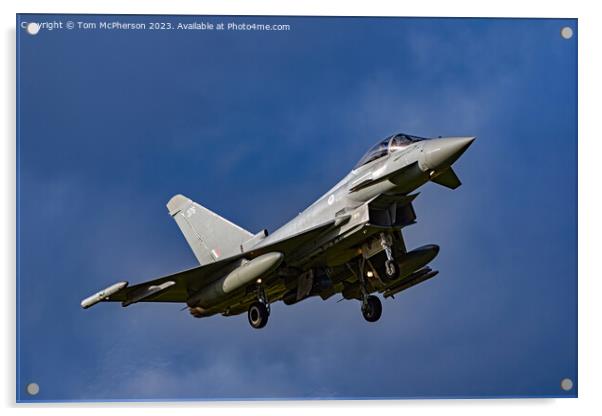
(0, 0, 602, 416)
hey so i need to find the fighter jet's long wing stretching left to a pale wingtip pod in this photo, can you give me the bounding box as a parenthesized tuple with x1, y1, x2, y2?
(81, 219, 340, 308)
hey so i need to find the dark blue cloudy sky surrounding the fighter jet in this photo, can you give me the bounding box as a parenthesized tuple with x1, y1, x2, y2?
(17, 15, 577, 401)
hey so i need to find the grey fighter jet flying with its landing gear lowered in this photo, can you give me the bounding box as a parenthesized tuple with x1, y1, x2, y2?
(81, 134, 475, 328)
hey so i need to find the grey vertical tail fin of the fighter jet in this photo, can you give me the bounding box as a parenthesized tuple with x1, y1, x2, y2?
(167, 195, 253, 264)
